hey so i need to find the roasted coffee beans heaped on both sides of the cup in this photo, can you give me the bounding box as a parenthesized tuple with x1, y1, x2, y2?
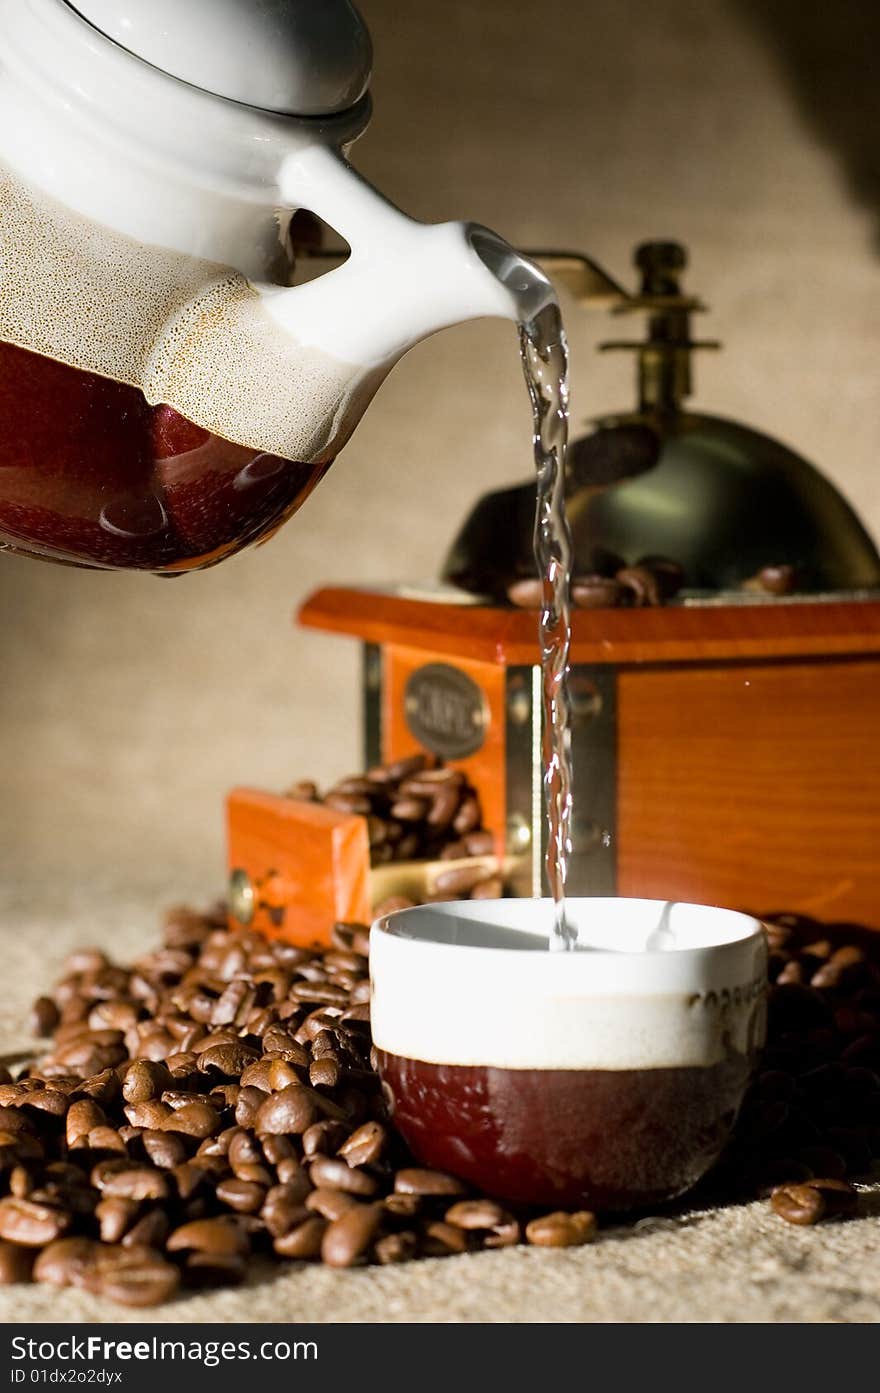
(0, 907, 880, 1307)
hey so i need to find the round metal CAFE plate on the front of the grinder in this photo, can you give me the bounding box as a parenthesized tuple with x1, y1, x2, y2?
(404, 663, 489, 759)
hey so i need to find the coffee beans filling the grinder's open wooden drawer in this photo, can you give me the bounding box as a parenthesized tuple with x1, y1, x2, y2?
(287, 754, 501, 900)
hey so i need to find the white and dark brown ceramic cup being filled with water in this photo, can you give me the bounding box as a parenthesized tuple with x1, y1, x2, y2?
(370, 898, 767, 1211)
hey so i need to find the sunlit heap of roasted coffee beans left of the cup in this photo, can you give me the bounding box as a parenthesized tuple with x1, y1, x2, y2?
(0, 910, 595, 1305)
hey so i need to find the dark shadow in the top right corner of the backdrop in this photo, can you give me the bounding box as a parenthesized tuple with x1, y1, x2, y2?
(734, 0, 880, 254)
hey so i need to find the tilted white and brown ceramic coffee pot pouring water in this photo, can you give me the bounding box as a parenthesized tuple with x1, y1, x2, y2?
(0, 0, 550, 574)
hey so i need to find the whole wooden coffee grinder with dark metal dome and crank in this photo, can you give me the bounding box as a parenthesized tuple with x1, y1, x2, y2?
(230, 242, 880, 936)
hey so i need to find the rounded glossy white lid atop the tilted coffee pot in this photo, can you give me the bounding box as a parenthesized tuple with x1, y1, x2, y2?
(71, 0, 372, 116)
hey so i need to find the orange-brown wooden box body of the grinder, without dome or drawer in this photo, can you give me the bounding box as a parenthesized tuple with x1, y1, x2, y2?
(293, 588, 880, 928)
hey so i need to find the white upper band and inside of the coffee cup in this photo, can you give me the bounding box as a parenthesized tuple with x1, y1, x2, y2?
(370, 898, 767, 1070)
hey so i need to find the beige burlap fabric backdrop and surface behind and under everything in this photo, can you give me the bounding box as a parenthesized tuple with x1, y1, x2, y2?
(0, 0, 880, 1321)
